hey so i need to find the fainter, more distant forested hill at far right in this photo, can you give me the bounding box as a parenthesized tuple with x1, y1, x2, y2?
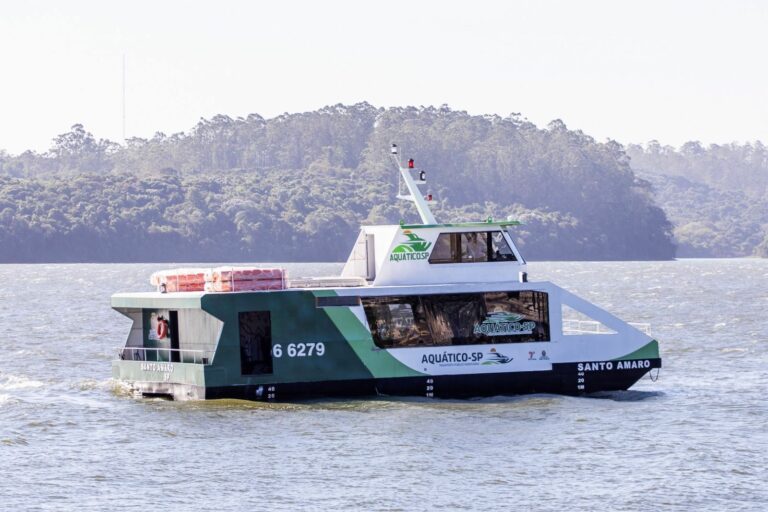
(627, 141, 768, 257)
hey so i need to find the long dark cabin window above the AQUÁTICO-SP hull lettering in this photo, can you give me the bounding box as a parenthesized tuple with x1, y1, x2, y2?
(362, 291, 549, 348)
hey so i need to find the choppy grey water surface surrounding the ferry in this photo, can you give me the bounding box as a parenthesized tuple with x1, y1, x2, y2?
(0, 260, 768, 511)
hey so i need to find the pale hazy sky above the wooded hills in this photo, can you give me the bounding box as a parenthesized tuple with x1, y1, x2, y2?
(0, 0, 768, 154)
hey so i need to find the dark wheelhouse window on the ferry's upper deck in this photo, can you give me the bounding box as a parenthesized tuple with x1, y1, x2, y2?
(429, 231, 517, 263)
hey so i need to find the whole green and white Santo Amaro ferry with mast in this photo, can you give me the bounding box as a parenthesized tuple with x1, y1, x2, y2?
(112, 145, 661, 401)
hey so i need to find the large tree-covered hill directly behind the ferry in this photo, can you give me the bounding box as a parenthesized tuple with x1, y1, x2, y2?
(0, 103, 674, 262)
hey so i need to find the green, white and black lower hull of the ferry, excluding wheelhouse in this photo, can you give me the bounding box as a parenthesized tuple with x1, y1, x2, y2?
(113, 283, 661, 401)
